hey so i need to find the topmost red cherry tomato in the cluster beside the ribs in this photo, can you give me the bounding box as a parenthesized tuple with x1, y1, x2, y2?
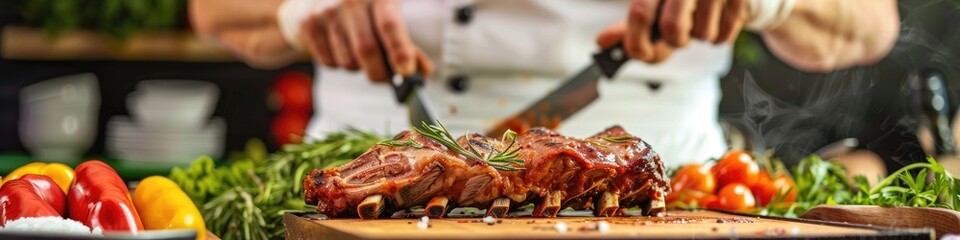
(712, 151, 760, 187)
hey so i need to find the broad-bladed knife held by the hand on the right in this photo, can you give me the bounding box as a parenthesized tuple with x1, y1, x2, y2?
(487, 28, 660, 136)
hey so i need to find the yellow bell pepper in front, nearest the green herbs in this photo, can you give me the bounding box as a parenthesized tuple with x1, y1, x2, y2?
(133, 176, 207, 240)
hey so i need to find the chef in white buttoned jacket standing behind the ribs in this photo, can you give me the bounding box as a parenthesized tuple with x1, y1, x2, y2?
(191, 0, 899, 165)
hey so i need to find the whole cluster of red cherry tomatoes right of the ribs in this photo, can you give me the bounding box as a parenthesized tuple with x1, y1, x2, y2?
(666, 151, 797, 212)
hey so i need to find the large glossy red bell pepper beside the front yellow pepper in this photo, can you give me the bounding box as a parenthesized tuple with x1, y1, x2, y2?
(67, 160, 143, 233)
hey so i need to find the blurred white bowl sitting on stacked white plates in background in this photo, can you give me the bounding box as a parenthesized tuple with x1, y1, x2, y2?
(106, 80, 226, 164)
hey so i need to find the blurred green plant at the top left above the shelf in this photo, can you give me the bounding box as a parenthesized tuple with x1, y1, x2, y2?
(18, 0, 187, 40)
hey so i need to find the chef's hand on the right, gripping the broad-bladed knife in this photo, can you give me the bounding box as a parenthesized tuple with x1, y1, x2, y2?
(597, 0, 747, 63)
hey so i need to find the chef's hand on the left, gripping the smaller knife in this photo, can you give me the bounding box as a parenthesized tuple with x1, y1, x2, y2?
(300, 0, 433, 82)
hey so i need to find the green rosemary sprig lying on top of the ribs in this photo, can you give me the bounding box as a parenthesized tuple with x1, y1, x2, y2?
(414, 120, 523, 171)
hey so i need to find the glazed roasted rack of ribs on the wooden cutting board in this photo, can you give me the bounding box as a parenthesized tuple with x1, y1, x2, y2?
(303, 126, 670, 219)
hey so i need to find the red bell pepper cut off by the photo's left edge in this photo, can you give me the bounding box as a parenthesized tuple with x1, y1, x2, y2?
(0, 179, 60, 226)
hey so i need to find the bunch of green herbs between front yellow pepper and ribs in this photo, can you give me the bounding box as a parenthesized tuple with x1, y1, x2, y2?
(170, 129, 386, 239)
